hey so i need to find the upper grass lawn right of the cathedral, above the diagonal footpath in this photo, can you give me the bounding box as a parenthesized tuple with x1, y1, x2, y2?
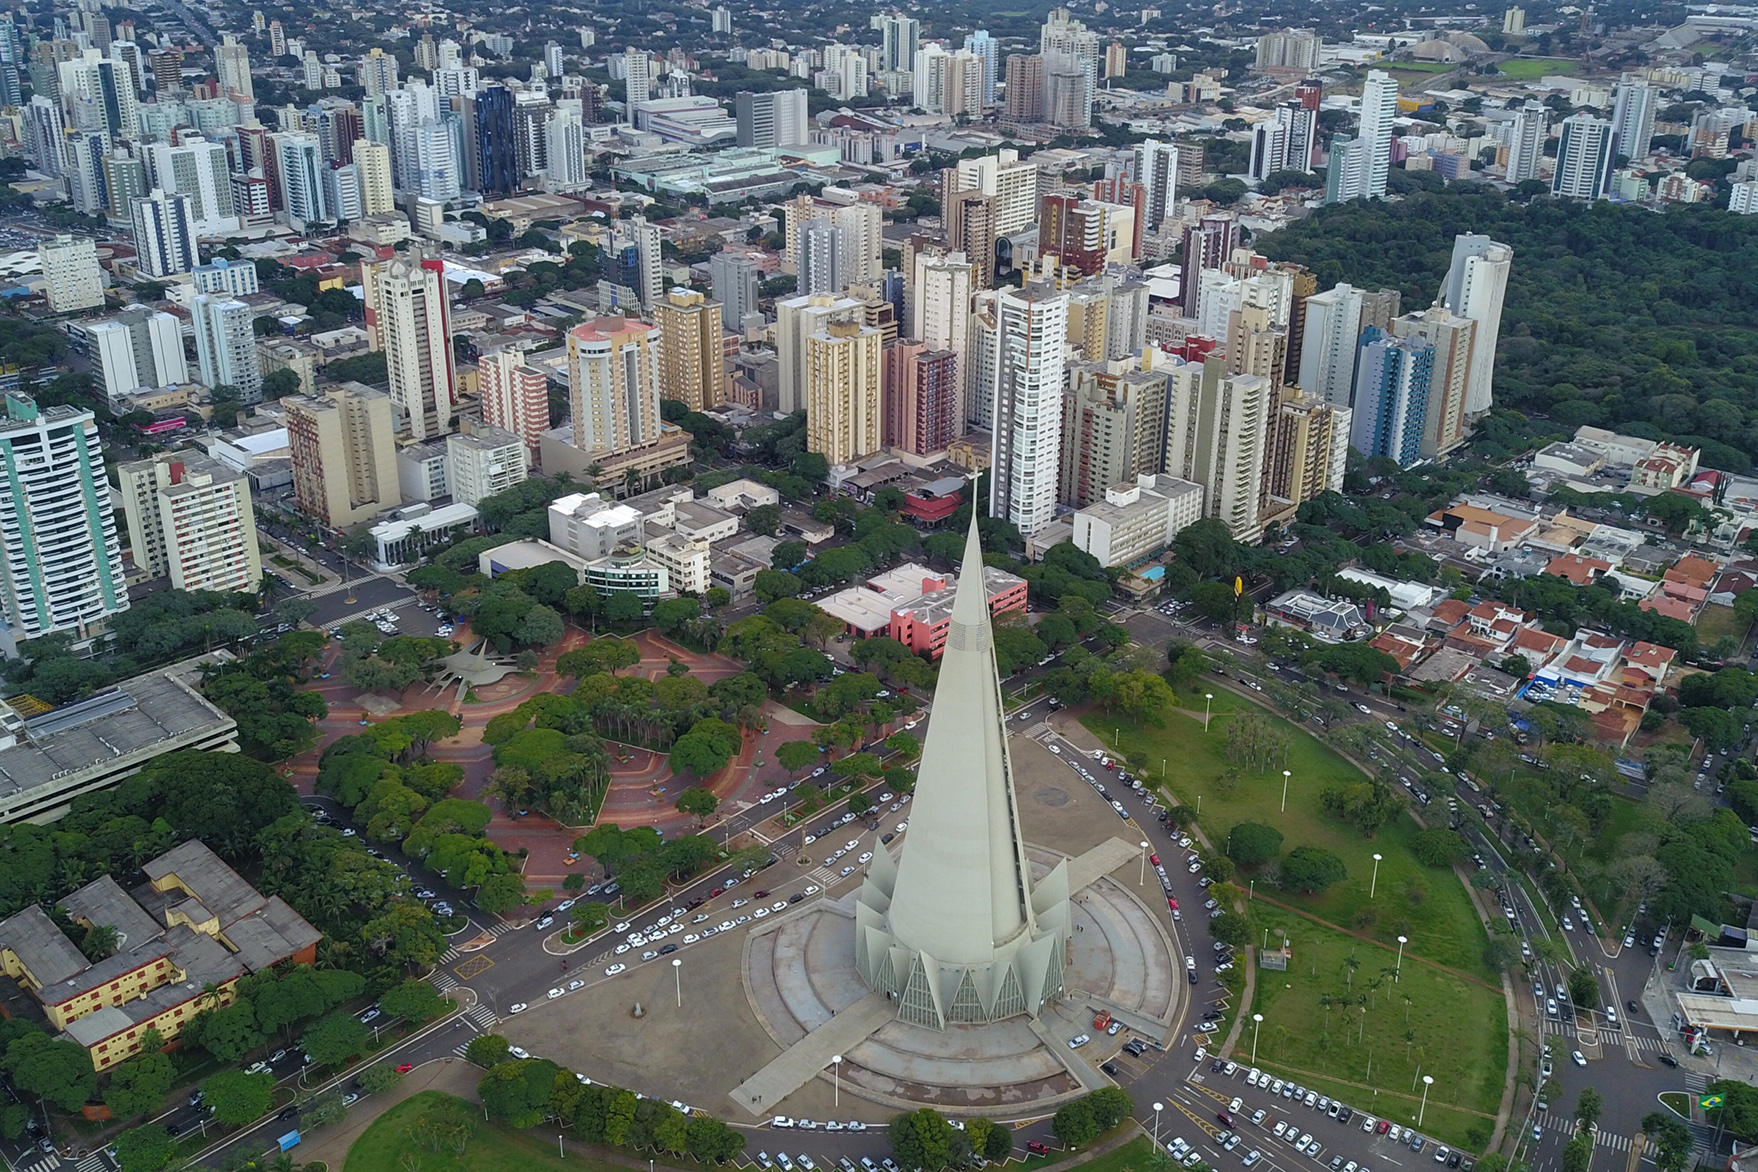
(1083, 691, 1498, 982)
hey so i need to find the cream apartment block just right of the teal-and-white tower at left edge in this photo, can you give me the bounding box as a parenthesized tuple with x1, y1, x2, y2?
(116, 452, 262, 594)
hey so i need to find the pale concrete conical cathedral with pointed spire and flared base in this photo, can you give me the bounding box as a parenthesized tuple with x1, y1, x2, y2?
(843, 518, 1069, 1026)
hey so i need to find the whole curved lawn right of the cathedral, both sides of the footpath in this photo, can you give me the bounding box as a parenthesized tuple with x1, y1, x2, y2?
(1085, 691, 1507, 1149)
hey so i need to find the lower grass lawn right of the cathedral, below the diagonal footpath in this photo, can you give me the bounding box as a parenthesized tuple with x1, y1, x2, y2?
(1234, 900, 1508, 1151)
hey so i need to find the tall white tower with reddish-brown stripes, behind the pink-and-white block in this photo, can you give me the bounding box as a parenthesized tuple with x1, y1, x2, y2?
(360, 257, 457, 439)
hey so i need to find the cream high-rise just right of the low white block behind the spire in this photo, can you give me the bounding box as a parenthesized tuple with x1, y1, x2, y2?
(1166, 355, 1276, 541)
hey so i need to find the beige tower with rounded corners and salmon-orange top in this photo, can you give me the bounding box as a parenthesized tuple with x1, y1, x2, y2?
(568, 318, 659, 453)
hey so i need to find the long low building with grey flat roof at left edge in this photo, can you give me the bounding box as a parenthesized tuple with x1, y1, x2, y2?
(0, 659, 237, 822)
